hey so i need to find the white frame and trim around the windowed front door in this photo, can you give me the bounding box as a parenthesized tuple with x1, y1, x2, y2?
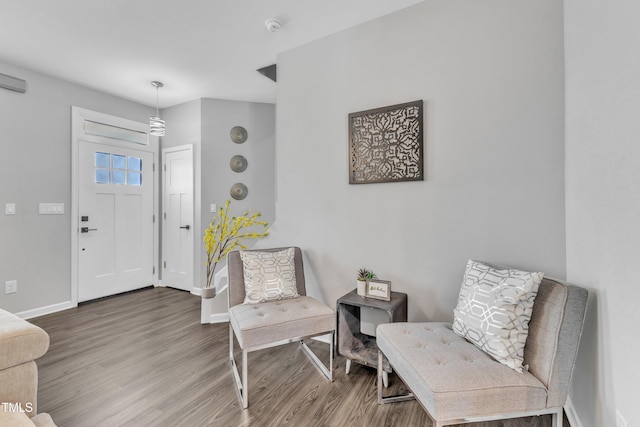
(70, 107, 160, 307)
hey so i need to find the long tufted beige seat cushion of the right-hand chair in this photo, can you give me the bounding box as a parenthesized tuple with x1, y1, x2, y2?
(377, 322, 547, 419)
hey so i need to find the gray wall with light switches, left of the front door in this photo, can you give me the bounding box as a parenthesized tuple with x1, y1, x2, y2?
(0, 63, 153, 312)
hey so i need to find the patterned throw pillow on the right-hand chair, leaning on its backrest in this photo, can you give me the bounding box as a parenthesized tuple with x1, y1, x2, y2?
(453, 260, 543, 372)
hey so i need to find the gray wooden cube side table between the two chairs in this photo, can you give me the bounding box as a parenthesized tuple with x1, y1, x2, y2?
(336, 289, 407, 387)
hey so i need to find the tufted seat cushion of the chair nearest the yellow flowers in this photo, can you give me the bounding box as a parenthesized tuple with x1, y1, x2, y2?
(229, 296, 335, 349)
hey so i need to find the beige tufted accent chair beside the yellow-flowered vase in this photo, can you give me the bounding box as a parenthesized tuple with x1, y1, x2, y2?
(227, 247, 335, 408)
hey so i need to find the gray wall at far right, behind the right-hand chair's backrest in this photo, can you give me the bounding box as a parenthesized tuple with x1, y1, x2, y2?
(565, 0, 640, 427)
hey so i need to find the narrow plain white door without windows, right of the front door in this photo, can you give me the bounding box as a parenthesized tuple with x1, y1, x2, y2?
(162, 145, 196, 291)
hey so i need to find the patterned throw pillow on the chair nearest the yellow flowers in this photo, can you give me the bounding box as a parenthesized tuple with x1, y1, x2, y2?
(240, 248, 299, 304)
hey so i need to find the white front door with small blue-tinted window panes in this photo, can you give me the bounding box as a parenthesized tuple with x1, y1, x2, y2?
(78, 141, 154, 301)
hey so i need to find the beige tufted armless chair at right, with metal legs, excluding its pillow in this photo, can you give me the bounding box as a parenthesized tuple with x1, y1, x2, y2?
(377, 266, 587, 427)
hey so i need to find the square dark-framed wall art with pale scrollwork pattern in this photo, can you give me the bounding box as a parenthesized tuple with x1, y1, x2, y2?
(349, 100, 424, 184)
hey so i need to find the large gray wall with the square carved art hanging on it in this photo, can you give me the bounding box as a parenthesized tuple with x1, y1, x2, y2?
(268, 0, 565, 320)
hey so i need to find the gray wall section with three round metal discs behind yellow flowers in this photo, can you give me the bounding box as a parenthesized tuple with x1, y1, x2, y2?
(161, 99, 275, 298)
